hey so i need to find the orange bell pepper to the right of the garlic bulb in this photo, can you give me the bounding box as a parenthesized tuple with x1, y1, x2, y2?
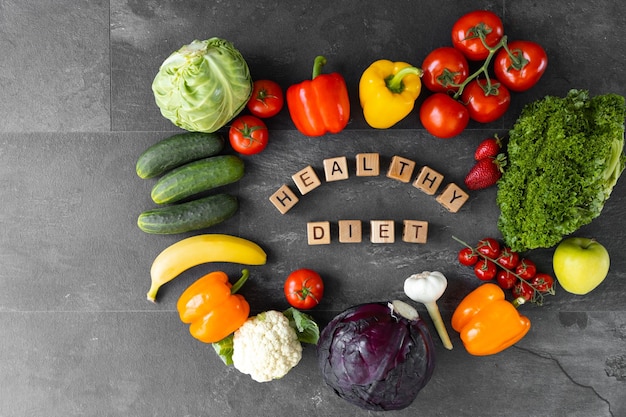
(452, 283, 530, 356)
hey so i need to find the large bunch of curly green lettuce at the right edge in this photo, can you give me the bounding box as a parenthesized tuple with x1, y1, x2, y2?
(496, 90, 626, 251)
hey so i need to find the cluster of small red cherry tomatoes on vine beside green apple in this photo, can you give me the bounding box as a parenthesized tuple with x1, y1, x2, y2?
(458, 237, 555, 304)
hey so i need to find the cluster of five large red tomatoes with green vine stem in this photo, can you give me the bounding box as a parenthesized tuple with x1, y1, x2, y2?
(420, 10, 548, 139)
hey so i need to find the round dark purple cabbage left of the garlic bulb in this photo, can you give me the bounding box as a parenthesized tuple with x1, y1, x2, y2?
(317, 301, 435, 411)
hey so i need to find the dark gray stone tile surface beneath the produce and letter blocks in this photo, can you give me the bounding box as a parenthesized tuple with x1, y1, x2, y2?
(0, 0, 626, 417)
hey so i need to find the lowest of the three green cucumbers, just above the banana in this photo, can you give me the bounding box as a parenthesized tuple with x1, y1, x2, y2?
(137, 194, 239, 235)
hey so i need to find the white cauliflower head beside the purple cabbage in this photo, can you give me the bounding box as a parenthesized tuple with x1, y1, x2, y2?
(233, 310, 302, 382)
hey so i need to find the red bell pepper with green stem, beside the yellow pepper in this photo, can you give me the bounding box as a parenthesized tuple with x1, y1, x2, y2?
(285, 56, 350, 136)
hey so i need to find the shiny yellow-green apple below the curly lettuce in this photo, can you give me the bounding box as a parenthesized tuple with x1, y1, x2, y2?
(552, 237, 610, 295)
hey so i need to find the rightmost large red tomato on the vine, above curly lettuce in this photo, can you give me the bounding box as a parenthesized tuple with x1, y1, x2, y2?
(493, 41, 548, 92)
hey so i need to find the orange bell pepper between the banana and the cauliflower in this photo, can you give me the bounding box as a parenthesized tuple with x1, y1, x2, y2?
(176, 269, 250, 343)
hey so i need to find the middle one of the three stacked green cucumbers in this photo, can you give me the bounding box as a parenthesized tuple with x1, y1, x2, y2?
(150, 155, 244, 204)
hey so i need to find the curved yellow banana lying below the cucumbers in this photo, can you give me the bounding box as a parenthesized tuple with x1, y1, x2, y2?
(148, 234, 267, 302)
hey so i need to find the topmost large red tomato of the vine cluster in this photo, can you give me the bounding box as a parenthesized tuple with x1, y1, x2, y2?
(452, 10, 504, 61)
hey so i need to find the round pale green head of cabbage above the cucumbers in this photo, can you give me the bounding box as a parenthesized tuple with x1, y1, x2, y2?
(152, 38, 252, 133)
